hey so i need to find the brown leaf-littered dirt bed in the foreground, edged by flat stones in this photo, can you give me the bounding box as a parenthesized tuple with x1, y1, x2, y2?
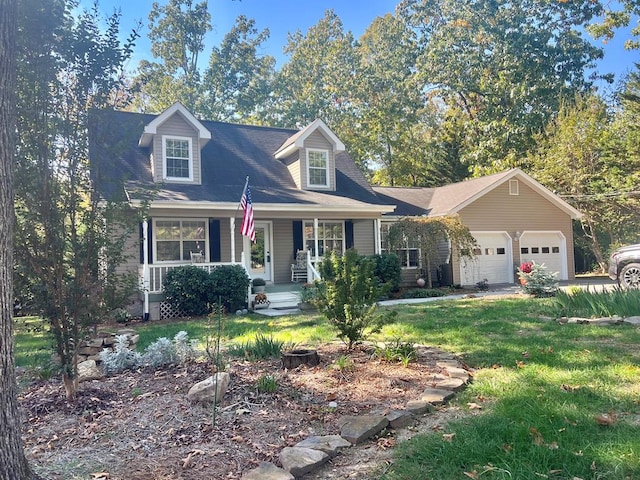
(19, 344, 472, 480)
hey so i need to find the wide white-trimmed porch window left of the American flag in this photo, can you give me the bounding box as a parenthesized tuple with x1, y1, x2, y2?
(153, 219, 208, 262)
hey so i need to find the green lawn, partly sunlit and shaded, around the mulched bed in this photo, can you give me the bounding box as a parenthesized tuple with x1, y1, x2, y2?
(16, 298, 640, 480)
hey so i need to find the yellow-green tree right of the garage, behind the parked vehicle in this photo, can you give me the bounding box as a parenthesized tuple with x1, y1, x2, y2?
(531, 95, 640, 271)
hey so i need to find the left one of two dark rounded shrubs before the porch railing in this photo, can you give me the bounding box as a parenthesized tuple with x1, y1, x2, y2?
(163, 265, 213, 316)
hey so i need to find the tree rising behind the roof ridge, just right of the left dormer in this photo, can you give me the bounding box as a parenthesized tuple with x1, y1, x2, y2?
(198, 15, 275, 122)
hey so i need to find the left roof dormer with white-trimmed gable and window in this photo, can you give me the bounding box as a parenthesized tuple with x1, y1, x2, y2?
(138, 102, 211, 184)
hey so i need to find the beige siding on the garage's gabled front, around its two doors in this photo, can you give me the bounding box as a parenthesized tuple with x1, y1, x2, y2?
(453, 181, 575, 283)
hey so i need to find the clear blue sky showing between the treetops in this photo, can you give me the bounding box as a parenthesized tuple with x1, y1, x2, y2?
(89, 0, 640, 92)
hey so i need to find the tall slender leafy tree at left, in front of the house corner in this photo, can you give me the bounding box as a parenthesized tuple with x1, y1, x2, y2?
(15, 0, 136, 398)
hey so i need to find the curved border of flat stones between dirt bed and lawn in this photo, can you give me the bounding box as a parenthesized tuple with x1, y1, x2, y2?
(241, 345, 471, 480)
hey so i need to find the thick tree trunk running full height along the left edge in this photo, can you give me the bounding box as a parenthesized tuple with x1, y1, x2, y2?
(0, 0, 36, 480)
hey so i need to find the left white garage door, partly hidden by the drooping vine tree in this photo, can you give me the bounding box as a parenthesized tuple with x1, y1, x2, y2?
(460, 232, 513, 285)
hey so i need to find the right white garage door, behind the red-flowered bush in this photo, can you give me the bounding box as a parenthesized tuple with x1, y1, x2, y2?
(520, 232, 567, 280)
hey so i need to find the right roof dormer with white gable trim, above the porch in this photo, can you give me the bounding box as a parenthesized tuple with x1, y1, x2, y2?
(274, 119, 345, 191)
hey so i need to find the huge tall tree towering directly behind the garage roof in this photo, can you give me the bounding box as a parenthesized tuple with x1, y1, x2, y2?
(399, 0, 603, 172)
